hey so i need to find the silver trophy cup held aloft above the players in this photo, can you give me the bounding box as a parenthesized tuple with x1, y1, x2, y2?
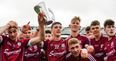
(34, 2, 54, 25)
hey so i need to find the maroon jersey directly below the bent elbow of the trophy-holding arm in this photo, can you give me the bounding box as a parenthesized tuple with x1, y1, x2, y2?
(24, 45, 41, 61)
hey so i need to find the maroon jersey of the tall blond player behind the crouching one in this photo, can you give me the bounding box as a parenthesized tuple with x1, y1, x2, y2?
(66, 34, 89, 48)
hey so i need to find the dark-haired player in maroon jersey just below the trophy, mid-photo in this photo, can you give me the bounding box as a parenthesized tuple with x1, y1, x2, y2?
(44, 22, 67, 61)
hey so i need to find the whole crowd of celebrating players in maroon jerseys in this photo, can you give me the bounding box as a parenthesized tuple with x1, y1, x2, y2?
(0, 13, 116, 61)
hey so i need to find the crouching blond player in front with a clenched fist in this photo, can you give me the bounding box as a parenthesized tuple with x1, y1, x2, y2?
(64, 38, 96, 61)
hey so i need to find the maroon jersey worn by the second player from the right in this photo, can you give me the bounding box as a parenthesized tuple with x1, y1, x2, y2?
(90, 36, 107, 61)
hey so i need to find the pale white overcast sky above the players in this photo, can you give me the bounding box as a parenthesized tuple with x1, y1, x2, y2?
(0, 0, 116, 27)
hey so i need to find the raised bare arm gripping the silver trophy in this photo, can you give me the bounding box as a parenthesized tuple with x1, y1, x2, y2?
(29, 13, 45, 45)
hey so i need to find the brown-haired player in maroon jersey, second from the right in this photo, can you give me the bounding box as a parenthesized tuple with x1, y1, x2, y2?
(90, 20, 107, 61)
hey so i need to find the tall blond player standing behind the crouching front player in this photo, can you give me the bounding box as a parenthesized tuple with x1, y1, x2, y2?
(67, 16, 89, 47)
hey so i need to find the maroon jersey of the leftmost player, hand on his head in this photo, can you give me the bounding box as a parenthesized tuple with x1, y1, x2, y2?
(1, 36, 28, 61)
